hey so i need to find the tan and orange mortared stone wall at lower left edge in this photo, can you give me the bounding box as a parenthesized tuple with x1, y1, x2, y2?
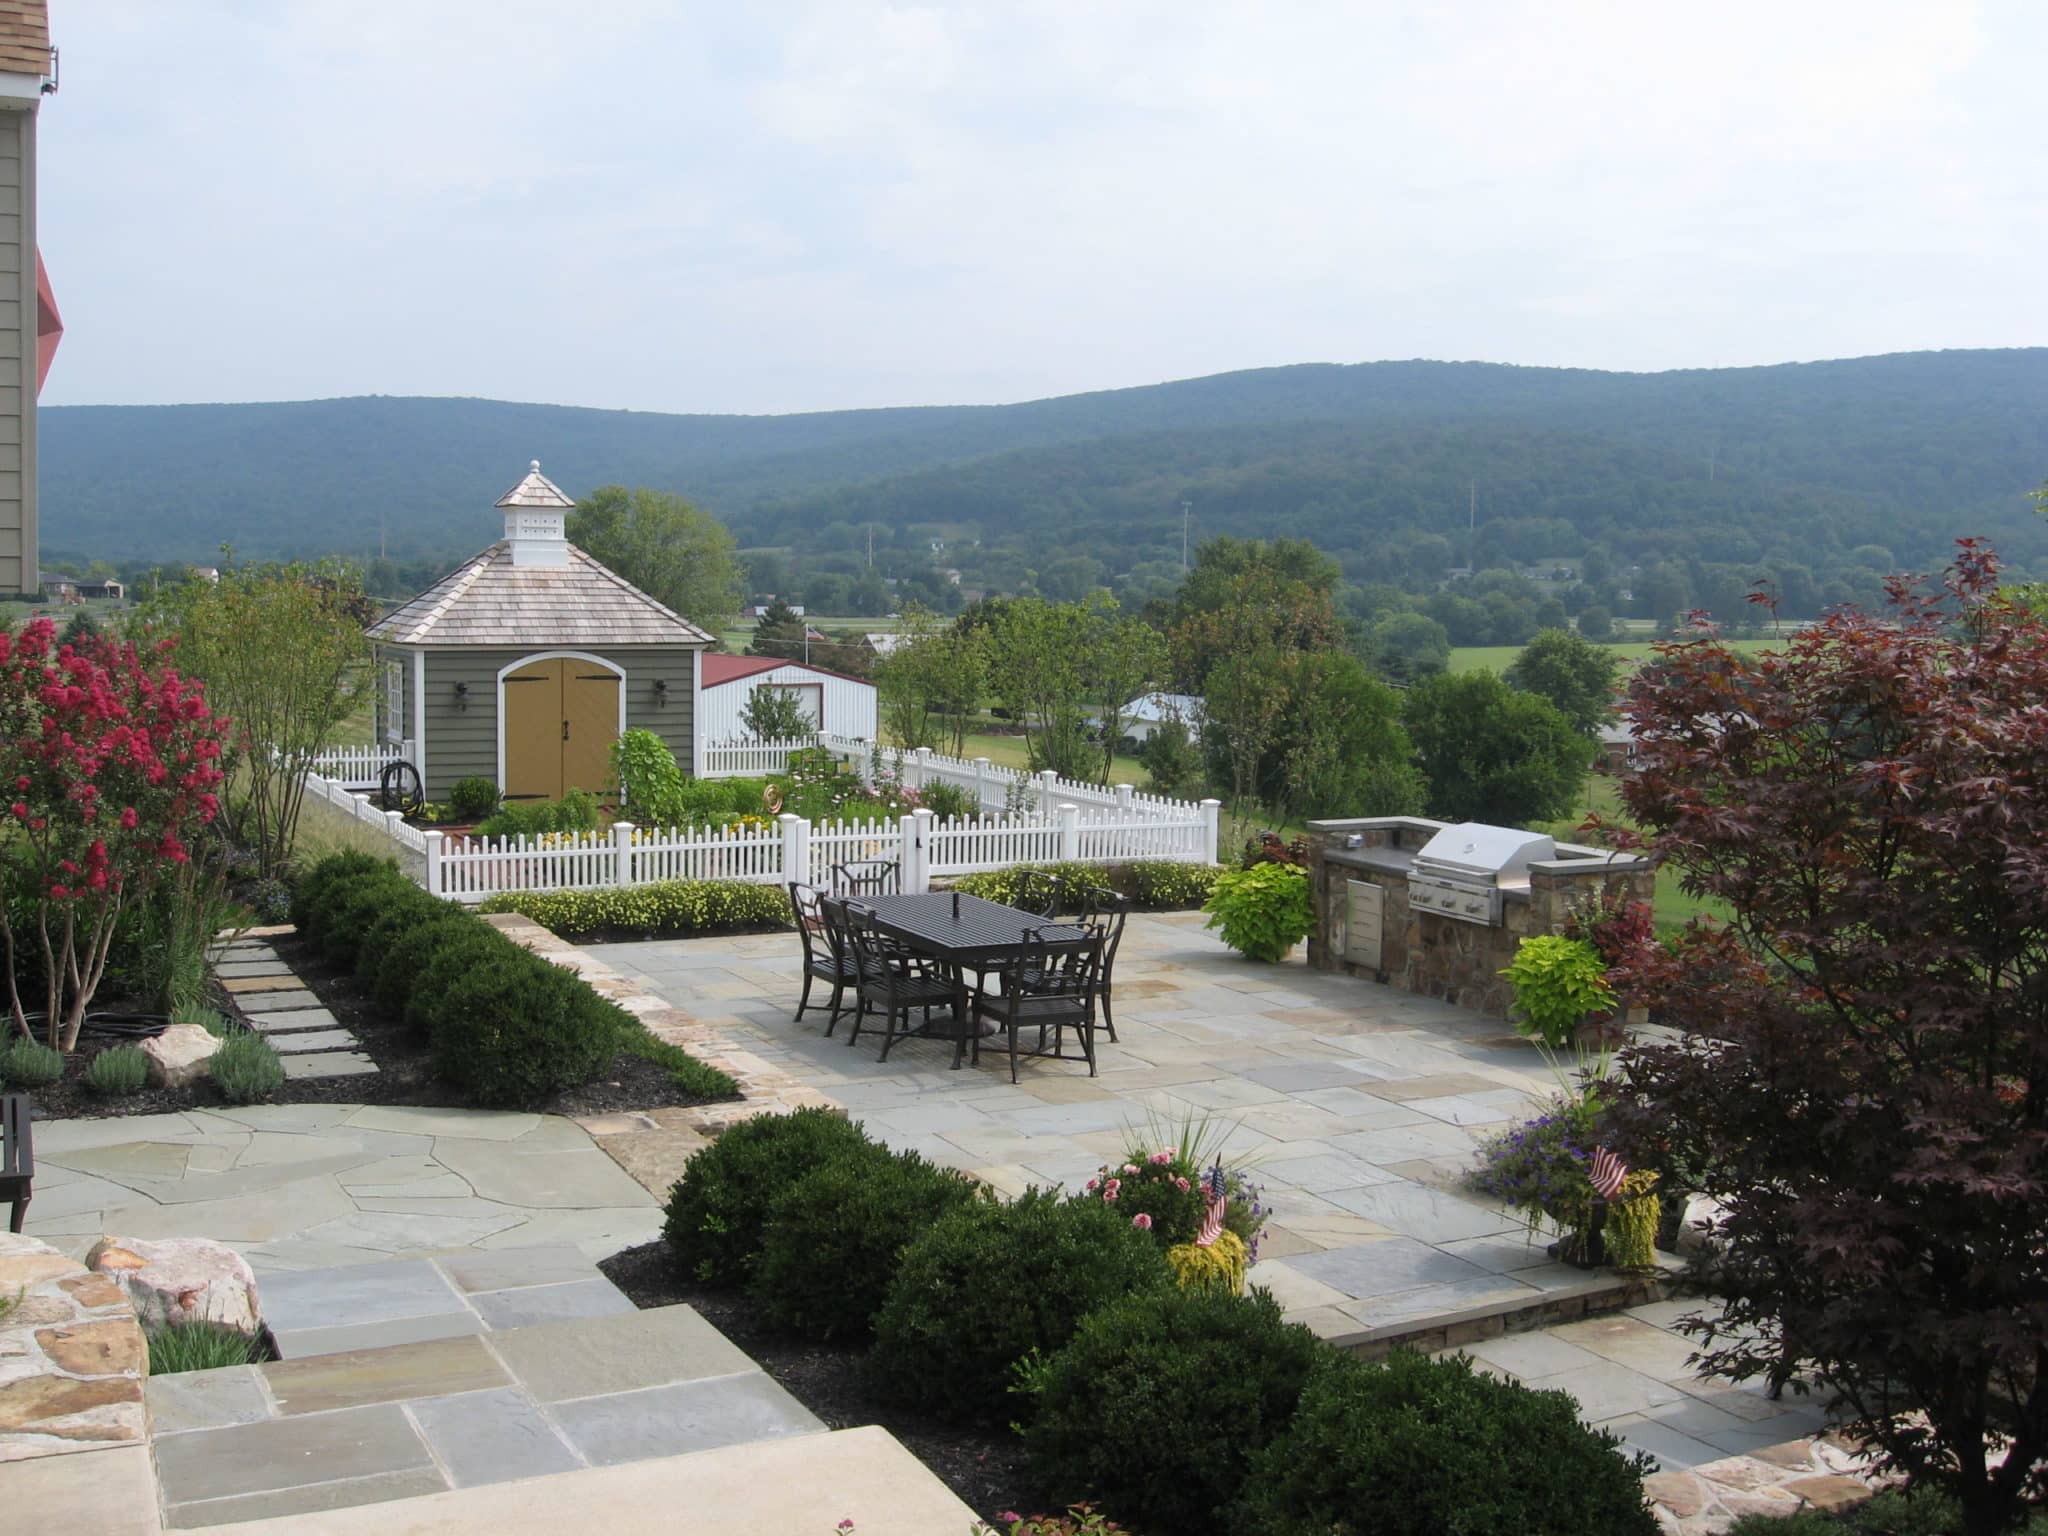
(0, 1233, 150, 1462)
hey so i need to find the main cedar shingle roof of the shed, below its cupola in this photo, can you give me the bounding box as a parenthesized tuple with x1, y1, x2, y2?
(366, 540, 711, 649)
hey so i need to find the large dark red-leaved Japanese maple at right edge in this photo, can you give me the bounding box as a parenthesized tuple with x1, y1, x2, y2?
(1612, 541, 2048, 1536)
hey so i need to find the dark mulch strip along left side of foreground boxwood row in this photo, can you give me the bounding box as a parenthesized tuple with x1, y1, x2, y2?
(598, 1243, 1047, 1522)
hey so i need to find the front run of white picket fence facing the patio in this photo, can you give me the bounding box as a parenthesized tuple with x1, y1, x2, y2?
(419, 801, 1219, 901)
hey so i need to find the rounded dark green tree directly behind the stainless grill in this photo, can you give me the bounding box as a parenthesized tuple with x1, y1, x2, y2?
(1403, 672, 1593, 825)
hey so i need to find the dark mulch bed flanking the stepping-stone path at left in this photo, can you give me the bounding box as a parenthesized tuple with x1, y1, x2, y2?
(25, 938, 741, 1120)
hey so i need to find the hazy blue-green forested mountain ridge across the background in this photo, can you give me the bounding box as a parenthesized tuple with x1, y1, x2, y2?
(41, 348, 2048, 614)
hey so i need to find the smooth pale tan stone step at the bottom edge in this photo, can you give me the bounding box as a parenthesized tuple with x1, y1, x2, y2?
(174, 1425, 975, 1536)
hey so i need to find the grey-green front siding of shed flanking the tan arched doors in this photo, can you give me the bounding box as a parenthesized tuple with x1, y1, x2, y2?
(420, 645, 694, 801)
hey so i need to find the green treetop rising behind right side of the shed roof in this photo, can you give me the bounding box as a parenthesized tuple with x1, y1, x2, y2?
(567, 485, 743, 635)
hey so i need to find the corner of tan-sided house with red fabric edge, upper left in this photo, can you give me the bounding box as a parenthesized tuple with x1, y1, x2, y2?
(0, 0, 63, 594)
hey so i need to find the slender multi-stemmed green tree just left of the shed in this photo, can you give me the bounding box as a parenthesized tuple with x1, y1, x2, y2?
(143, 565, 371, 874)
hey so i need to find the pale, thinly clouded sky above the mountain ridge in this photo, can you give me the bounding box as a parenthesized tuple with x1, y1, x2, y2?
(39, 0, 2048, 412)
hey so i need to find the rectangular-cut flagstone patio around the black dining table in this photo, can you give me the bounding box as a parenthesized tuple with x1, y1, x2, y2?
(581, 913, 1823, 1482)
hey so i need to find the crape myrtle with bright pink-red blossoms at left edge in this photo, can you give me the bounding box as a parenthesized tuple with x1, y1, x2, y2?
(0, 618, 227, 1051)
